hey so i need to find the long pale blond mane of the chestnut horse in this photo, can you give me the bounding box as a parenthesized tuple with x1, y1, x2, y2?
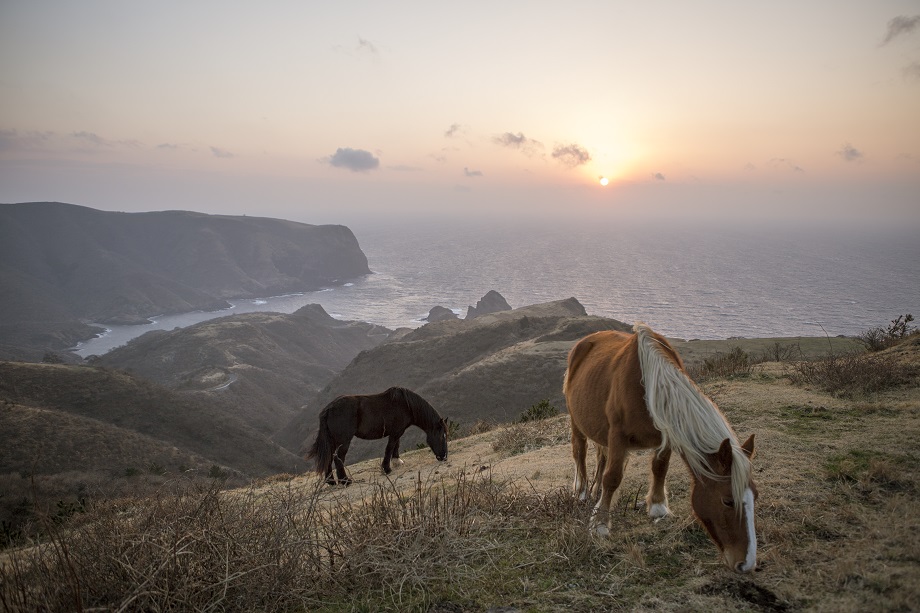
(633, 322, 751, 512)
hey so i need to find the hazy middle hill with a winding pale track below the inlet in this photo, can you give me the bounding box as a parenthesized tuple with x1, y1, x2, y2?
(95, 304, 390, 434)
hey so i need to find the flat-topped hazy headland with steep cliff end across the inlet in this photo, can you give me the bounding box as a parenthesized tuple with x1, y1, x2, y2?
(0, 202, 370, 359)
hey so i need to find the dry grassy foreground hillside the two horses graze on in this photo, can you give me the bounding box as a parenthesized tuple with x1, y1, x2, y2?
(0, 336, 920, 612)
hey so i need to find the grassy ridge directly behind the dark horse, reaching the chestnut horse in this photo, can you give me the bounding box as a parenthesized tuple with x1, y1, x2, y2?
(275, 298, 631, 460)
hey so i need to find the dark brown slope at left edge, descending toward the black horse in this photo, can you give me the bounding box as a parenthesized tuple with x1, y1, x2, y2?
(0, 362, 304, 521)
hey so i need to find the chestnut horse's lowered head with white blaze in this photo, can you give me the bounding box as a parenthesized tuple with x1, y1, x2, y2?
(690, 434, 757, 573)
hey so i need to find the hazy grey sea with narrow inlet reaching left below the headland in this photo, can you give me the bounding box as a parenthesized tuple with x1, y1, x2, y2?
(74, 219, 920, 357)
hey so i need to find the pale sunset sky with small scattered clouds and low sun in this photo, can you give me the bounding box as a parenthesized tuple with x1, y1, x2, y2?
(0, 0, 920, 228)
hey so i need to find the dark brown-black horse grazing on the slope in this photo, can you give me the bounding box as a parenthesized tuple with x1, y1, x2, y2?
(306, 387, 447, 485)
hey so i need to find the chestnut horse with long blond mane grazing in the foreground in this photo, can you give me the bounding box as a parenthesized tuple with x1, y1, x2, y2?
(563, 323, 757, 572)
